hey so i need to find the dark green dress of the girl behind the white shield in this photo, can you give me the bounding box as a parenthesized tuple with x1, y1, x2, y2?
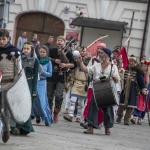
(17, 59, 39, 135)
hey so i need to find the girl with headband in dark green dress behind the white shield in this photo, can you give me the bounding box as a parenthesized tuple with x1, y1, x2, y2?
(16, 42, 39, 135)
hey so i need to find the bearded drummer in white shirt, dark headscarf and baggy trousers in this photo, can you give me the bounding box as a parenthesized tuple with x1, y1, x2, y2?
(78, 48, 120, 135)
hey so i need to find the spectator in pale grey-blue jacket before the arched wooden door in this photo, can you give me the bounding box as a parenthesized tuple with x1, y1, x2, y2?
(17, 31, 27, 51)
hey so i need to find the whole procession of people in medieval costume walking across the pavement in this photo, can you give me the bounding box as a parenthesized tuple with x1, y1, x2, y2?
(0, 29, 150, 143)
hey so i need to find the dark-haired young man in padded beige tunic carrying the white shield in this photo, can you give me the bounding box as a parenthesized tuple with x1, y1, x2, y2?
(0, 29, 20, 143)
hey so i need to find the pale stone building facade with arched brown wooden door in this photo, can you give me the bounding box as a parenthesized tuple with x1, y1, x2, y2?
(7, 0, 150, 58)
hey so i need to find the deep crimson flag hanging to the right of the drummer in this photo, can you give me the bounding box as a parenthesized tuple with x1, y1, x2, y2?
(117, 47, 129, 69)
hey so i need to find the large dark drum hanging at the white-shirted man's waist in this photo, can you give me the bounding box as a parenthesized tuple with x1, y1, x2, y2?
(93, 78, 119, 109)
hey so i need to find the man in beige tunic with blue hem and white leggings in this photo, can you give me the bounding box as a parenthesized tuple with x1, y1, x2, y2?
(64, 46, 91, 122)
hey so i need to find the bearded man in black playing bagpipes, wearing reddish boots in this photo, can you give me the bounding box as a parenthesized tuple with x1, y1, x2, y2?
(47, 35, 75, 122)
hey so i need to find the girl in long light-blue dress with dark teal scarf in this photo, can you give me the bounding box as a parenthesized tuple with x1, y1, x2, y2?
(32, 45, 54, 126)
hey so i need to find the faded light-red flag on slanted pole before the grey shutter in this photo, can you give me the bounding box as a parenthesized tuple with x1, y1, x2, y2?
(87, 38, 101, 57)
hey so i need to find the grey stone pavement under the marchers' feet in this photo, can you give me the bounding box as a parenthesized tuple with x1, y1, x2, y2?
(0, 103, 150, 150)
